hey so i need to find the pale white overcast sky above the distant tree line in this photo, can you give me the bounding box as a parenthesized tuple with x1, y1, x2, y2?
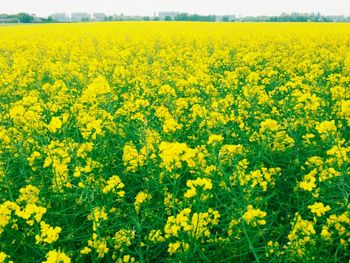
(0, 0, 350, 16)
